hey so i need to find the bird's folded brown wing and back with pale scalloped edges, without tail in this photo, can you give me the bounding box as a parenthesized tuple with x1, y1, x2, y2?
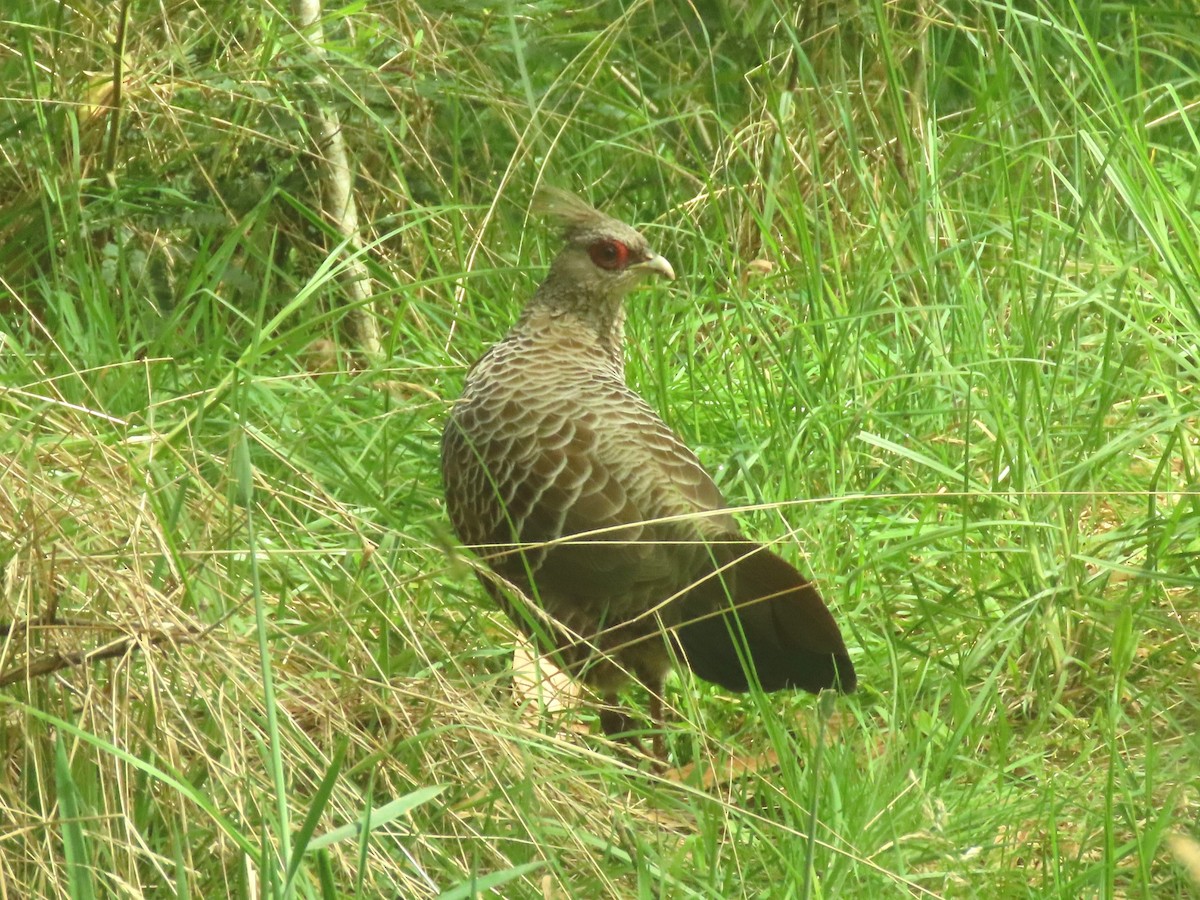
(443, 380, 736, 614)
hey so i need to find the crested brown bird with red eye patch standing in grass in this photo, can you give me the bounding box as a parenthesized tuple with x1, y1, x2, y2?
(442, 187, 857, 758)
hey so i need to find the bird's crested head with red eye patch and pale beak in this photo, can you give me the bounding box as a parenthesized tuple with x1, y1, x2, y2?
(533, 187, 674, 300)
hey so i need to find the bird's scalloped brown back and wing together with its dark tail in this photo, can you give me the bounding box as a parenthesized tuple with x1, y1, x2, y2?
(443, 367, 856, 691)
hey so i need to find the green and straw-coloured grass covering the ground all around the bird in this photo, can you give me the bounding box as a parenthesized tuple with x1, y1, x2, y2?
(0, 0, 1200, 898)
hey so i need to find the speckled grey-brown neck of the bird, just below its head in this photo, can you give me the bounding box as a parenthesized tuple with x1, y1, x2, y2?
(517, 278, 625, 371)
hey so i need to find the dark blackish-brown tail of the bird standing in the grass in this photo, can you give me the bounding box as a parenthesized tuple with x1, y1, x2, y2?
(676, 539, 858, 694)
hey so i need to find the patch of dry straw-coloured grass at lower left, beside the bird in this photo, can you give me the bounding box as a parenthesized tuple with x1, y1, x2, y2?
(0, 372, 667, 896)
